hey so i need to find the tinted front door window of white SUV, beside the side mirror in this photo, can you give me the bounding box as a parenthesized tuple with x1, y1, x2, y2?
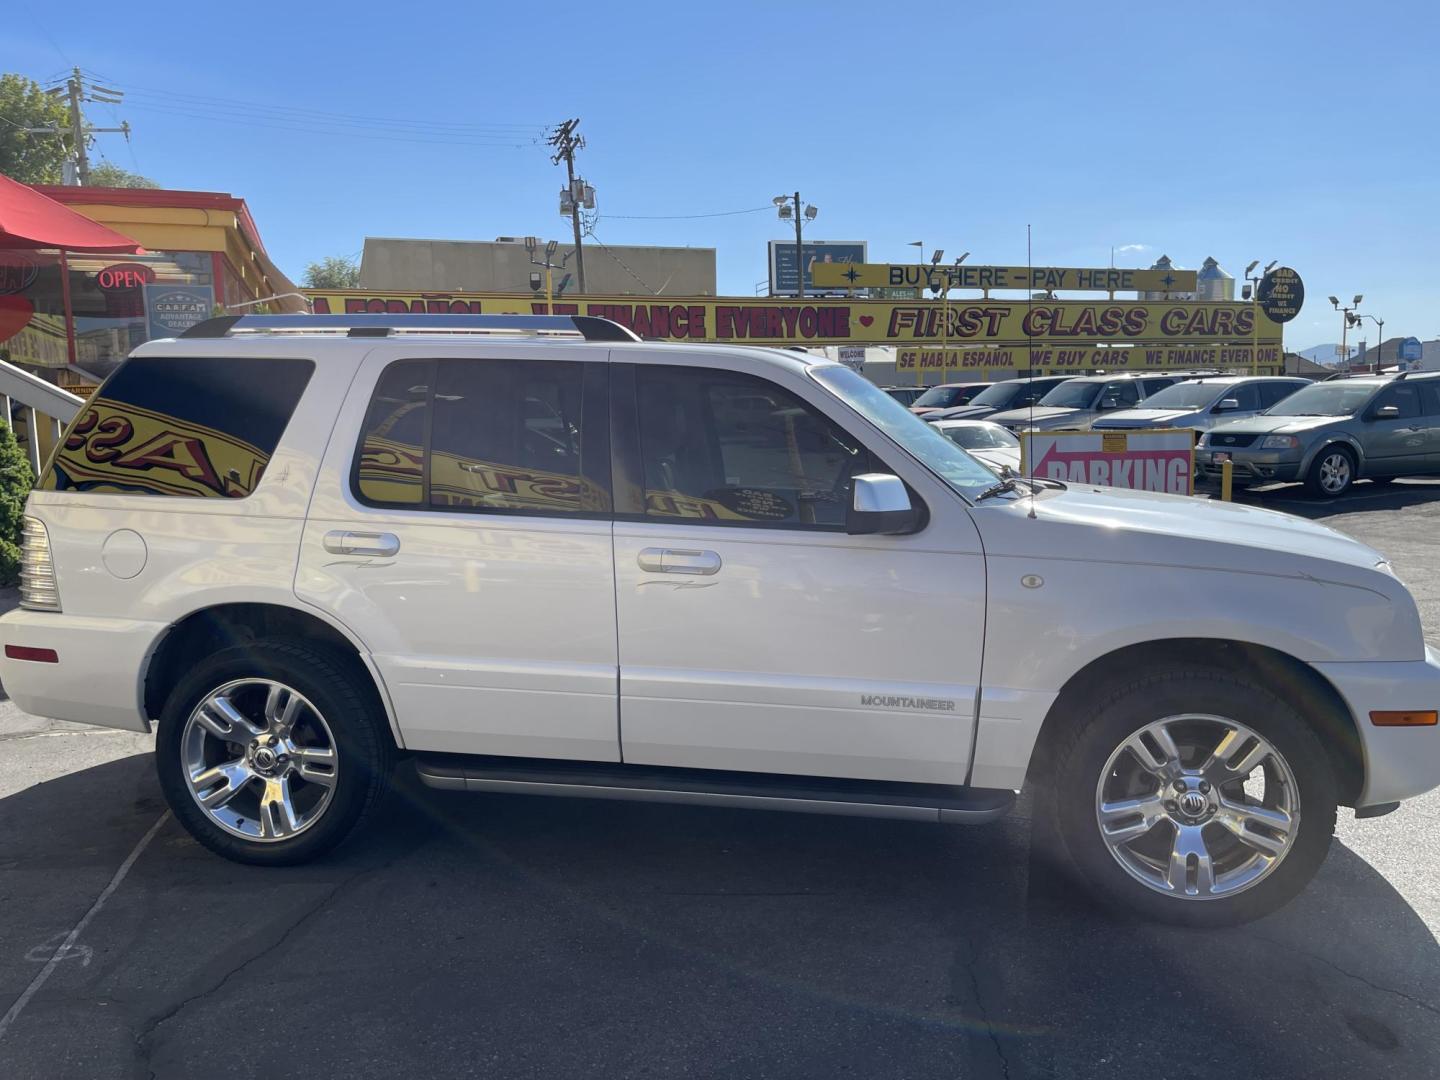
(635, 364, 873, 530)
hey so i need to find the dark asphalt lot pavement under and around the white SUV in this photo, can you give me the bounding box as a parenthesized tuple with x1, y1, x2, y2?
(0, 482, 1440, 1080)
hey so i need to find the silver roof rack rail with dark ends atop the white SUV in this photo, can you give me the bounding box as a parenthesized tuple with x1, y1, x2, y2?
(180, 312, 639, 341)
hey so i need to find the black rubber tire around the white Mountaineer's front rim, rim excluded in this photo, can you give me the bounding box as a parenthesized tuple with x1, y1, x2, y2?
(1041, 668, 1336, 927)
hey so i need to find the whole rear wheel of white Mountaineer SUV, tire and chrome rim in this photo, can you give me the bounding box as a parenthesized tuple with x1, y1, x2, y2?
(156, 641, 393, 865)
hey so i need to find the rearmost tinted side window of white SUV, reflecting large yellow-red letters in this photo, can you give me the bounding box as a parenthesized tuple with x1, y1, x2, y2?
(40, 357, 315, 498)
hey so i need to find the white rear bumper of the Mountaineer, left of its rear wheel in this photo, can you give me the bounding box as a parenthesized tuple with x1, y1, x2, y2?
(0, 611, 166, 732)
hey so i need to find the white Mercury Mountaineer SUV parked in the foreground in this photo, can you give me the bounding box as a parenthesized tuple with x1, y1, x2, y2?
(0, 315, 1440, 924)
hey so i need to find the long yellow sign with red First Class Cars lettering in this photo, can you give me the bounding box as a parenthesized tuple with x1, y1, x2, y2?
(308, 289, 1280, 348)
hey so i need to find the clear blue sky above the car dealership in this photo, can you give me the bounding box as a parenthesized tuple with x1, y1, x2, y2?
(0, 0, 1440, 348)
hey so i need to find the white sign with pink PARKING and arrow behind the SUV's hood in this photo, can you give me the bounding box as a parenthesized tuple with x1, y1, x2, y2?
(1020, 428, 1195, 495)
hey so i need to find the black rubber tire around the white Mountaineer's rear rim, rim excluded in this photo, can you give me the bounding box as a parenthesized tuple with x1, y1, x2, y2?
(156, 639, 395, 865)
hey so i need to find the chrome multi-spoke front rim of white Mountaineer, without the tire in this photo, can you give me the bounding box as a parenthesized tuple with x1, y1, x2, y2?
(1094, 713, 1300, 900)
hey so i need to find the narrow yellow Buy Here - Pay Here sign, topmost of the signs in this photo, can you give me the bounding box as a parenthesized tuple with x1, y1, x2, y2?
(811, 262, 1197, 292)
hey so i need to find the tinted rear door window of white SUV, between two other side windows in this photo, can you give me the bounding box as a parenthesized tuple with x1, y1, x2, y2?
(354, 360, 611, 514)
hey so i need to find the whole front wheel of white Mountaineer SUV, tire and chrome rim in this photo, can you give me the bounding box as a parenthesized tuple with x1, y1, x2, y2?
(1048, 670, 1336, 926)
